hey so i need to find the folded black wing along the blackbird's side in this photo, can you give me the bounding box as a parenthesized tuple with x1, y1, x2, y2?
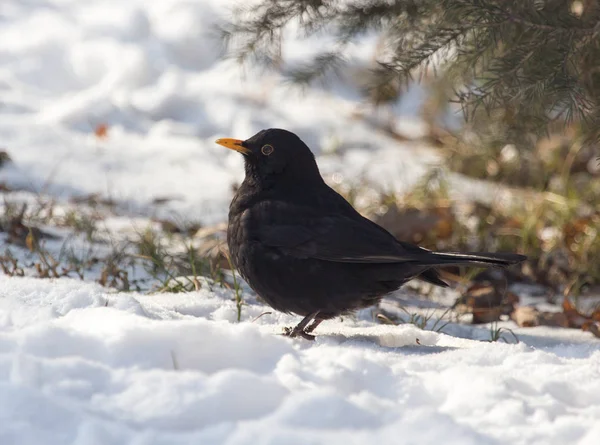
(257, 215, 428, 263)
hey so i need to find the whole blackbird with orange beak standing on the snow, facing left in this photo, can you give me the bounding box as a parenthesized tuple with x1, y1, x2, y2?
(216, 129, 525, 339)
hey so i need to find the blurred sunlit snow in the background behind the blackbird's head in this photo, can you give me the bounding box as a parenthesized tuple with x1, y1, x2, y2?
(0, 0, 436, 222)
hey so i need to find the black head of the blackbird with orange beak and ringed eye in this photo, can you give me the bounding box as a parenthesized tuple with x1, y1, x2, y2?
(216, 128, 323, 186)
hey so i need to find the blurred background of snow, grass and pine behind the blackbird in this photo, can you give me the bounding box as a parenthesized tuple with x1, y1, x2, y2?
(0, 0, 600, 317)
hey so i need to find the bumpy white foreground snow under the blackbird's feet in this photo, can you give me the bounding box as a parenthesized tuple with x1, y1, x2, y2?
(0, 277, 600, 444)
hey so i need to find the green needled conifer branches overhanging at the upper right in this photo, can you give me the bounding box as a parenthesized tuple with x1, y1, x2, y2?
(223, 0, 600, 142)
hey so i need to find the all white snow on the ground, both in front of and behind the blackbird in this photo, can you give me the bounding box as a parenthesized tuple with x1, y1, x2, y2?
(0, 0, 600, 445)
